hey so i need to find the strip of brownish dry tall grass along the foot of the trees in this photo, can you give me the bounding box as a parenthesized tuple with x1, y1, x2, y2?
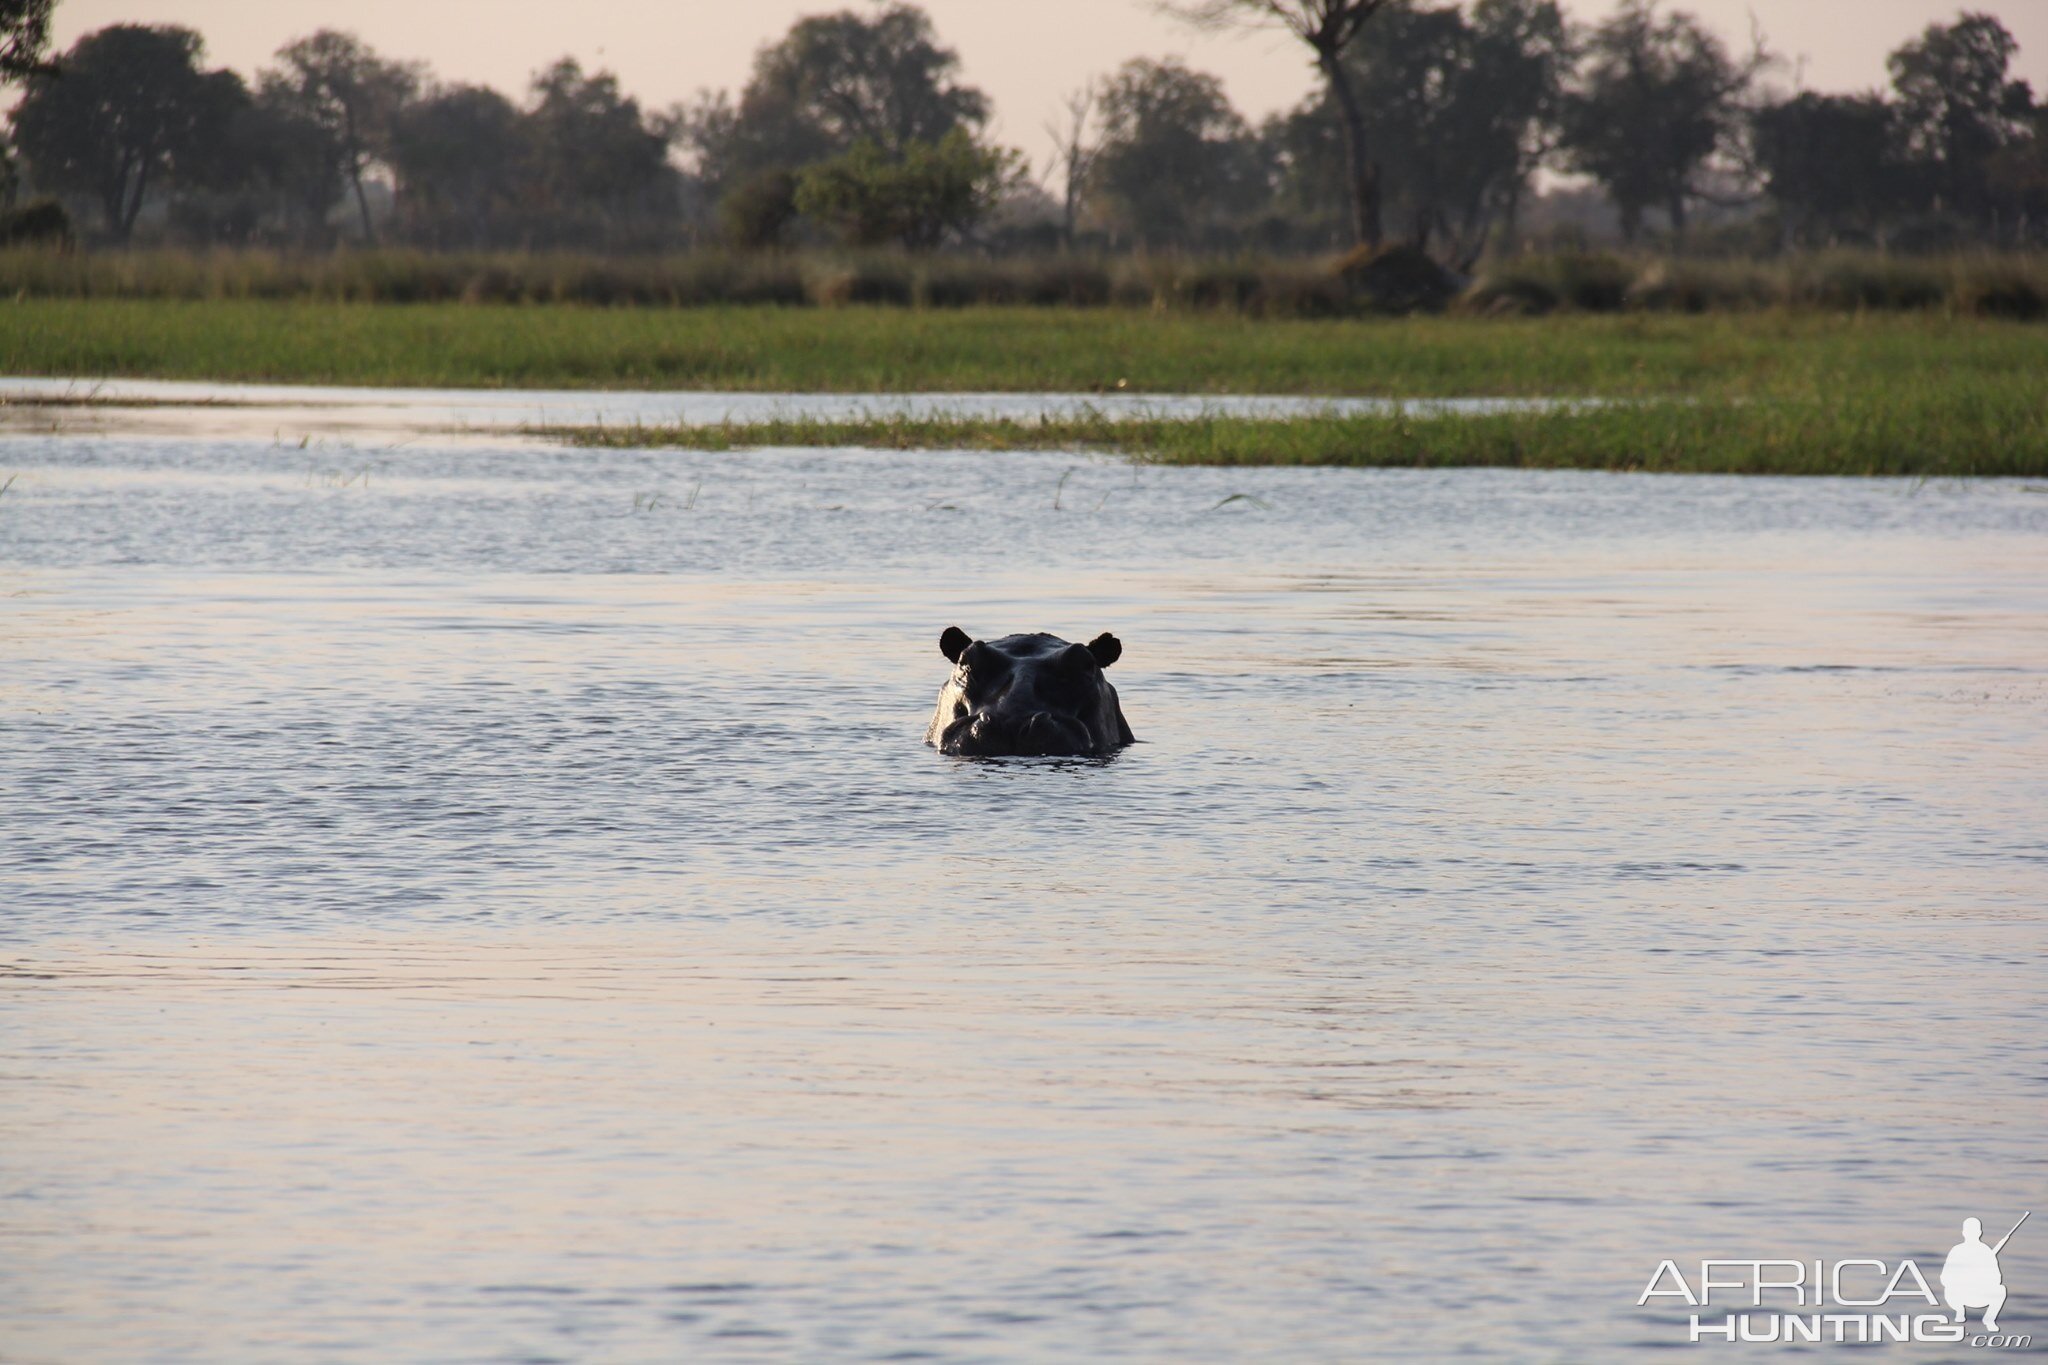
(0, 244, 2048, 321)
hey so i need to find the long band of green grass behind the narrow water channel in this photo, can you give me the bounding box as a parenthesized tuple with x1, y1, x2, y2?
(0, 299, 2048, 397)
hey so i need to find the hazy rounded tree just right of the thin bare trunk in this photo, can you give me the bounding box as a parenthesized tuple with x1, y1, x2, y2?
(1092, 57, 1264, 246)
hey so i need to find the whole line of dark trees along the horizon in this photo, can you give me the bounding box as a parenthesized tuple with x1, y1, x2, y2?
(0, 0, 2048, 258)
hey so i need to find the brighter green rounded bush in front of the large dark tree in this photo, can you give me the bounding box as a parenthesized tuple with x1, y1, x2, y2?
(795, 129, 1016, 252)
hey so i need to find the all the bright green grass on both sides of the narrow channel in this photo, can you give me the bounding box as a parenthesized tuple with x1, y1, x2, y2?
(0, 299, 2048, 477)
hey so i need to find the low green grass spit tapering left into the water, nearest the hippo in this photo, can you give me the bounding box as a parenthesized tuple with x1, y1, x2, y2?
(545, 385, 2048, 477)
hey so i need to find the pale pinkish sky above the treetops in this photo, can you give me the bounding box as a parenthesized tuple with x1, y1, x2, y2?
(44, 0, 2048, 170)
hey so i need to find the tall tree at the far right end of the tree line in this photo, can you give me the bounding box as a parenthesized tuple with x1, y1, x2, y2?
(1888, 14, 2034, 219)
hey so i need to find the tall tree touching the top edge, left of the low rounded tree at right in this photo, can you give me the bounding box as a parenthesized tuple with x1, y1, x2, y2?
(1563, 0, 1769, 241)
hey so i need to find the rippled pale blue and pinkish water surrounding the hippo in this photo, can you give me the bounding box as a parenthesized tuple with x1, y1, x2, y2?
(0, 420, 2048, 1361)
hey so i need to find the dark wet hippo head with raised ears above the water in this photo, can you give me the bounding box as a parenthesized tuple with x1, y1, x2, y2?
(924, 626, 1130, 757)
